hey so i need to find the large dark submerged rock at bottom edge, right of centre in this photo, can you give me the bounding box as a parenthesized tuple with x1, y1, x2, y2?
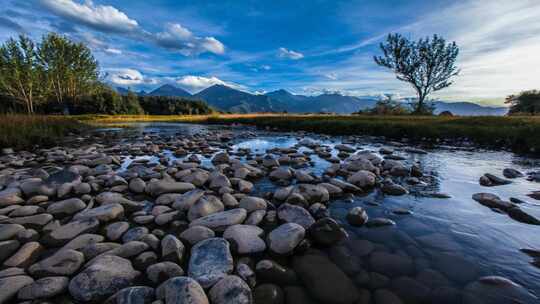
(294, 255, 359, 304)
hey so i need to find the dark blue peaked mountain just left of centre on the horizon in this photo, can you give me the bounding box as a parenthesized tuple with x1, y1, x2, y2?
(193, 84, 287, 113)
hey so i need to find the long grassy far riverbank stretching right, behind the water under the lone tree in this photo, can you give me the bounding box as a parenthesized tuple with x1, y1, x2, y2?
(78, 114, 540, 154)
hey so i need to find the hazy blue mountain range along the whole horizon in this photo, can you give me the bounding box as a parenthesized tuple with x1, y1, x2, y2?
(117, 84, 507, 116)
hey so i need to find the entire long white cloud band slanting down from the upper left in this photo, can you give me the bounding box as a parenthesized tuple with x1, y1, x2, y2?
(41, 0, 225, 56)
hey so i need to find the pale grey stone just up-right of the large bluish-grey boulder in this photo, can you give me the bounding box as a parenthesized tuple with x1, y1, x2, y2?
(223, 225, 266, 254)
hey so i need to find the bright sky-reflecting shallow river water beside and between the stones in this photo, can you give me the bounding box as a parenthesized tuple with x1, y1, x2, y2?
(103, 123, 540, 296)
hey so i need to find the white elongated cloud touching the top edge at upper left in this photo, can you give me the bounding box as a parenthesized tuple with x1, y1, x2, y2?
(41, 0, 139, 33)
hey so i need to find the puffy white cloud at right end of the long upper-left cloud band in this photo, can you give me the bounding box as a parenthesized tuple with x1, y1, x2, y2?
(154, 23, 225, 56)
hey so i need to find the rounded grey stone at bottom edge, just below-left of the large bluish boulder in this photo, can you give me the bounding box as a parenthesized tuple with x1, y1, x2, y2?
(156, 277, 209, 304)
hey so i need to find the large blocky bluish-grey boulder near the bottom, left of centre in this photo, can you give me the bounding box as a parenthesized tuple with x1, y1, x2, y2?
(188, 238, 233, 288)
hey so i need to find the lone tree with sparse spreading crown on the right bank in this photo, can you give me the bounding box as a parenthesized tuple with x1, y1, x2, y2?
(373, 34, 459, 114)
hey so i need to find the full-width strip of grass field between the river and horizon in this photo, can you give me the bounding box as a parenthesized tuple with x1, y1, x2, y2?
(0, 114, 540, 154)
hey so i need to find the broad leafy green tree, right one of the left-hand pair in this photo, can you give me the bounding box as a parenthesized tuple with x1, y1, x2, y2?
(38, 33, 99, 106)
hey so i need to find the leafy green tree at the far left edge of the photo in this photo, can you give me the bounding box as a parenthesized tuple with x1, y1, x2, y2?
(0, 35, 43, 114)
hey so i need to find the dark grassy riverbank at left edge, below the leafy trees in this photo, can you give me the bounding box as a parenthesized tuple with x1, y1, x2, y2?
(0, 115, 89, 149)
